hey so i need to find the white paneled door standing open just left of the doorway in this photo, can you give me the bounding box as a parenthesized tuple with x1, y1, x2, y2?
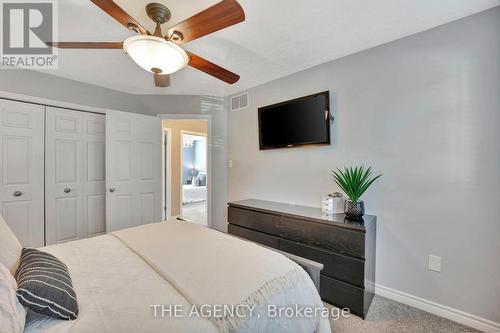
(106, 111, 162, 232)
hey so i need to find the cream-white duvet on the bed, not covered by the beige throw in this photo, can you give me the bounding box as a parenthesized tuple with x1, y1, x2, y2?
(25, 222, 330, 333)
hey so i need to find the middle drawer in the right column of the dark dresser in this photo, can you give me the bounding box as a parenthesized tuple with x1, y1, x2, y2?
(279, 239, 365, 288)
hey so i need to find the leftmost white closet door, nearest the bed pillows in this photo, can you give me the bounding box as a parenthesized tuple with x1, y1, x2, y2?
(0, 99, 44, 247)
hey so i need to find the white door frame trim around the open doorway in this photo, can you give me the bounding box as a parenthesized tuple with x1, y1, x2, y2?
(158, 113, 213, 228)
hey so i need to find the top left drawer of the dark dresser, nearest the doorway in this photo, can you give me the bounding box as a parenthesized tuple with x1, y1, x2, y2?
(228, 207, 280, 236)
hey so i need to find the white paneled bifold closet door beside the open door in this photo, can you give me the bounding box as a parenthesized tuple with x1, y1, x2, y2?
(45, 107, 106, 245)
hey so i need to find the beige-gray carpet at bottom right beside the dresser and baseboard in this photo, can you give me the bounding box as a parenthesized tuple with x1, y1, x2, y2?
(325, 296, 478, 333)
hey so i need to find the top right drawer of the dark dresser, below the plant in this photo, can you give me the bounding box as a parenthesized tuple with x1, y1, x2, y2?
(278, 217, 365, 259)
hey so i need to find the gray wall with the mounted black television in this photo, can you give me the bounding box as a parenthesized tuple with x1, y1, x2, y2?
(226, 7, 500, 322)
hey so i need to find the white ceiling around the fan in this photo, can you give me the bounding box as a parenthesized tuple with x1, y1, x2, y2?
(36, 0, 500, 96)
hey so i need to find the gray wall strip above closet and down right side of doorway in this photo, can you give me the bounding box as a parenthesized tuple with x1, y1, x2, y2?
(0, 69, 227, 230)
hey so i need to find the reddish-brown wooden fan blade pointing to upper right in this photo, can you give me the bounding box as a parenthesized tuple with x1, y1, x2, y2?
(167, 0, 245, 44)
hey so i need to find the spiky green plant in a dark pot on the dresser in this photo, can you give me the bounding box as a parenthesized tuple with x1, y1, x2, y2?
(332, 166, 382, 220)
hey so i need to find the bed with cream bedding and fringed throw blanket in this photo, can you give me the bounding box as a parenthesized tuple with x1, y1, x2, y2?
(20, 221, 331, 333)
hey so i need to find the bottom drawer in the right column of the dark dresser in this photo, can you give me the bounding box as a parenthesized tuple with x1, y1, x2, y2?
(320, 274, 366, 318)
